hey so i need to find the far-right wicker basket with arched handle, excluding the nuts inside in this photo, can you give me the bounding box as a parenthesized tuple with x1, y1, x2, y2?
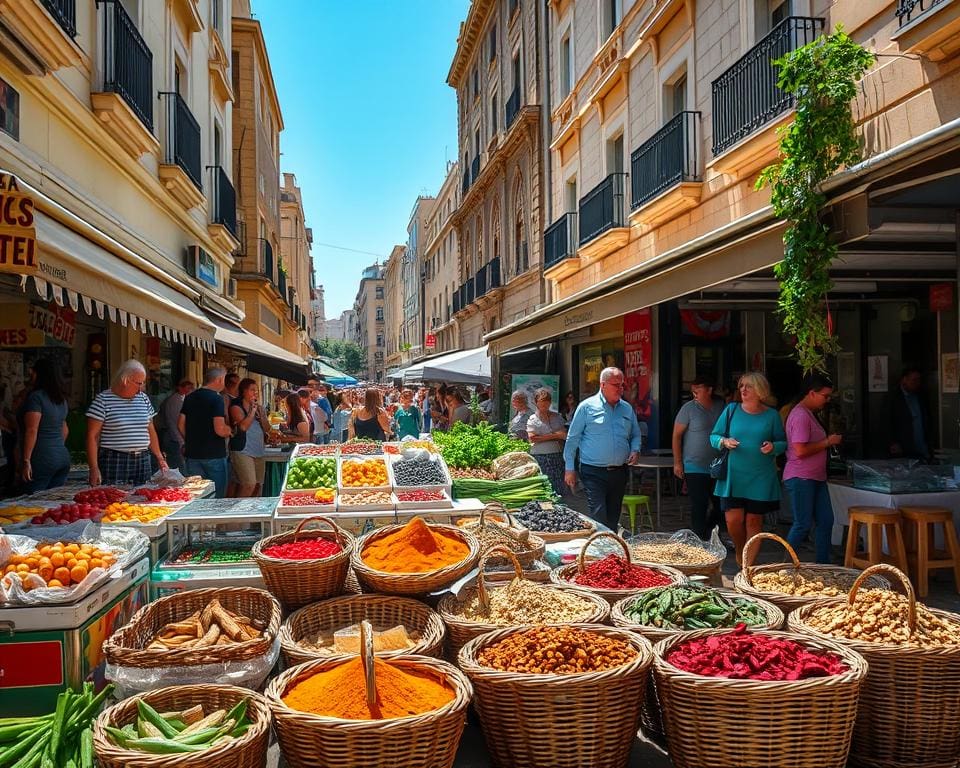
(787, 564, 960, 768)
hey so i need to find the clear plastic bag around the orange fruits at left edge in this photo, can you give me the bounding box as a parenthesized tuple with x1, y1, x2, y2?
(0, 520, 150, 605)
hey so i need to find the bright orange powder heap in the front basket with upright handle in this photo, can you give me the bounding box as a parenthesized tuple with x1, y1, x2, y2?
(283, 656, 454, 720)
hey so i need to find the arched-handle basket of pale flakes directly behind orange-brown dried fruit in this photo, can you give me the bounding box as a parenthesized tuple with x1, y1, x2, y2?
(437, 545, 610, 658)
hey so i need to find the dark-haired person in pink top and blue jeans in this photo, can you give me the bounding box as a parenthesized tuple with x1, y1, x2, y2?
(783, 373, 843, 563)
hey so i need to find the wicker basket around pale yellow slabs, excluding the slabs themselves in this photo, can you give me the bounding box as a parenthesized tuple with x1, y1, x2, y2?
(280, 595, 446, 667)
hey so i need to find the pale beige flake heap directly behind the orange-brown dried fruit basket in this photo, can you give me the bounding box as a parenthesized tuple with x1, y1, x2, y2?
(450, 579, 594, 627)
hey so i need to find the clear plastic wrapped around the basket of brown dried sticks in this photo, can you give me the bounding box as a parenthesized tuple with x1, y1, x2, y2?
(104, 637, 280, 698)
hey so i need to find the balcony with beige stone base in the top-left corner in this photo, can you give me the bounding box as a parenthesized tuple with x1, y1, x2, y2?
(0, 0, 82, 75)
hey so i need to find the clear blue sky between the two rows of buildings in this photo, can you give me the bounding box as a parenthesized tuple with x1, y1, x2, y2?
(253, 0, 469, 318)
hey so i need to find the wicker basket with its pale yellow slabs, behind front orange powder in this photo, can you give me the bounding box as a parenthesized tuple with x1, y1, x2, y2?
(280, 595, 447, 667)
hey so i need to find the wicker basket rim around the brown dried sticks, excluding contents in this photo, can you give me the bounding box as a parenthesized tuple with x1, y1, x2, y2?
(103, 587, 280, 669)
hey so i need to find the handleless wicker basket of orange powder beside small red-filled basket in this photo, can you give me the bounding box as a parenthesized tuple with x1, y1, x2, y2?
(351, 517, 480, 595)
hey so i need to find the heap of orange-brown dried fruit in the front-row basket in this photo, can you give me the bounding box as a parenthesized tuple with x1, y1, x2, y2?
(477, 627, 637, 675)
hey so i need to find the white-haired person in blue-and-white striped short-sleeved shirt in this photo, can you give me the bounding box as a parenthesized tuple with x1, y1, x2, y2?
(87, 360, 167, 485)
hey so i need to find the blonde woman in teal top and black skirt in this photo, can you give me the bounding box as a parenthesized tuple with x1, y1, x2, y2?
(710, 373, 787, 565)
